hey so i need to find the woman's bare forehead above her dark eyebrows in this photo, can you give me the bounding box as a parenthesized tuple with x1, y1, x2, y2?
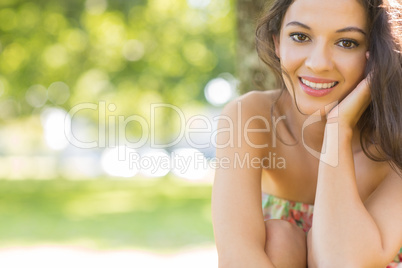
(283, 0, 367, 30)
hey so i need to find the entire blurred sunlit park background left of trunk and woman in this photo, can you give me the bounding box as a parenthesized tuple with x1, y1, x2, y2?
(0, 0, 238, 267)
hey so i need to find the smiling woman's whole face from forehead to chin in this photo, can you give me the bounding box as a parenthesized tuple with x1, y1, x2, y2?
(275, 0, 368, 114)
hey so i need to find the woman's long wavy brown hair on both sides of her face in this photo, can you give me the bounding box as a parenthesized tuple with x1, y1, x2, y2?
(256, 0, 402, 173)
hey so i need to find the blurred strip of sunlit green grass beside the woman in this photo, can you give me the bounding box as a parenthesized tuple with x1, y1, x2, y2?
(0, 177, 213, 251)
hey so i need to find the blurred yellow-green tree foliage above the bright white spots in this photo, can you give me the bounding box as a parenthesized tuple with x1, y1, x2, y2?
(0, 0, 235, 119)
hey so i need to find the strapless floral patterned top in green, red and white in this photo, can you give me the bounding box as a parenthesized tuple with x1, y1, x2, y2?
(262, 193, 402, 268)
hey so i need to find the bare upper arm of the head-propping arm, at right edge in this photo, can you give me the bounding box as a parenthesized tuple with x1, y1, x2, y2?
(365, 170, 402, 259)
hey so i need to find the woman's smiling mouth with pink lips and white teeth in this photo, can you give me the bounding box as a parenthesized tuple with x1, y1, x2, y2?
(299, 77, 338, 97)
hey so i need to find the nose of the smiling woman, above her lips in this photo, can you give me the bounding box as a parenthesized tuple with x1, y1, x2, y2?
(305, 43, 334, 73)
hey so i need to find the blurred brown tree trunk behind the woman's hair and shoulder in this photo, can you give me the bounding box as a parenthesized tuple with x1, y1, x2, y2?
(236, 0, 275, 93)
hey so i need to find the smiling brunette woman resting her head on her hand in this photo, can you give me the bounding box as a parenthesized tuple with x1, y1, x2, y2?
(212, 0, 402, 268)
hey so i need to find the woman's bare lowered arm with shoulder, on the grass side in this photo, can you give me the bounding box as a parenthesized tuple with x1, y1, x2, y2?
(212, 92, 269, 264)
